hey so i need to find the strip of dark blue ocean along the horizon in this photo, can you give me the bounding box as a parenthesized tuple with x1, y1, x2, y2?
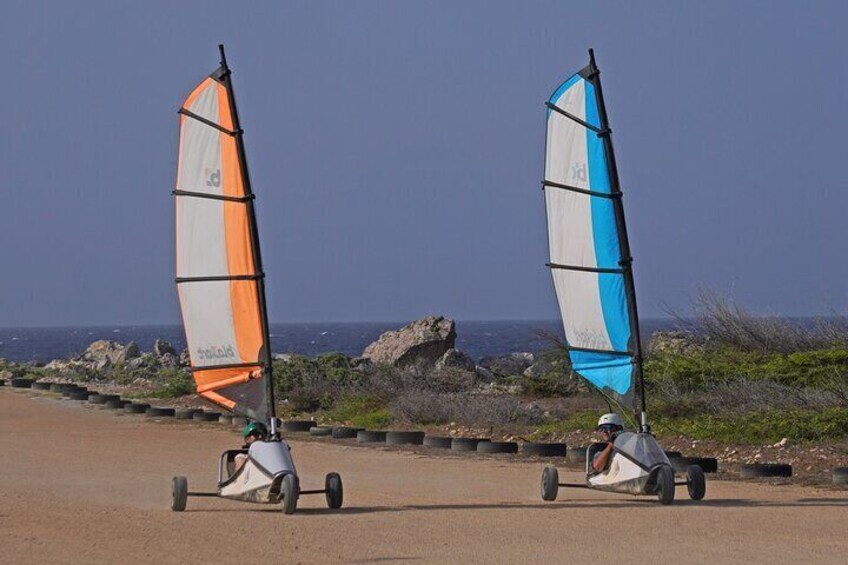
(0, 319, 675, 363)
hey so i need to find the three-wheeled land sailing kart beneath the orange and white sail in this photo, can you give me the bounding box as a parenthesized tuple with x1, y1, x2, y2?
(171, 424, 344, 514)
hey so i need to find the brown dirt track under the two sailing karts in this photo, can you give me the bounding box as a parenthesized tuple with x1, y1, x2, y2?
(0, 389, 848, 565)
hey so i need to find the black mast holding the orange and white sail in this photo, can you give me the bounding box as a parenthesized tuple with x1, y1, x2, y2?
(218, 44, 277, 424)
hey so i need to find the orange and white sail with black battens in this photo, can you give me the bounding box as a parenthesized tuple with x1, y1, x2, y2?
(174, 51, 273, 420)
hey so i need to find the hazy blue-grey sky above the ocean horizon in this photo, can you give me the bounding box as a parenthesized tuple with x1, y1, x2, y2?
(0, 0, 848, 326)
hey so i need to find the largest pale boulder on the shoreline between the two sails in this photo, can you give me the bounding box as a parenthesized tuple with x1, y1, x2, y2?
(362, 316, 456, 367)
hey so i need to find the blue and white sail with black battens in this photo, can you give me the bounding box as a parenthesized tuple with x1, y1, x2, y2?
(542, 57, 641, 408)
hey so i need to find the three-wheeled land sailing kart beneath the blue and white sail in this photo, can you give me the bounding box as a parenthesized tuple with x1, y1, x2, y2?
(541, 432, 706, 504)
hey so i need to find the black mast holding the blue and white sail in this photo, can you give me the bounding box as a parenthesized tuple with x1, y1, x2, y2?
(586, 49, 648, 431)
